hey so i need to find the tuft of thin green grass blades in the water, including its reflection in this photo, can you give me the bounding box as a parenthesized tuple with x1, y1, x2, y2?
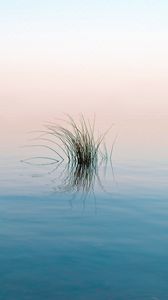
(22, 115, 116, 197)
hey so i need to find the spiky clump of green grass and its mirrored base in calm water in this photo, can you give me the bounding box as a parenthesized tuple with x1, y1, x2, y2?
(22, 115, 114, 192)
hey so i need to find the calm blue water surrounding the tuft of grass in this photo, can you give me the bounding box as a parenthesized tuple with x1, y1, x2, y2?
(0, 120, 168, 300)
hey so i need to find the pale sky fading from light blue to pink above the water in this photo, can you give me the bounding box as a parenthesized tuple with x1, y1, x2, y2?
(0, 0, 168, 132)
